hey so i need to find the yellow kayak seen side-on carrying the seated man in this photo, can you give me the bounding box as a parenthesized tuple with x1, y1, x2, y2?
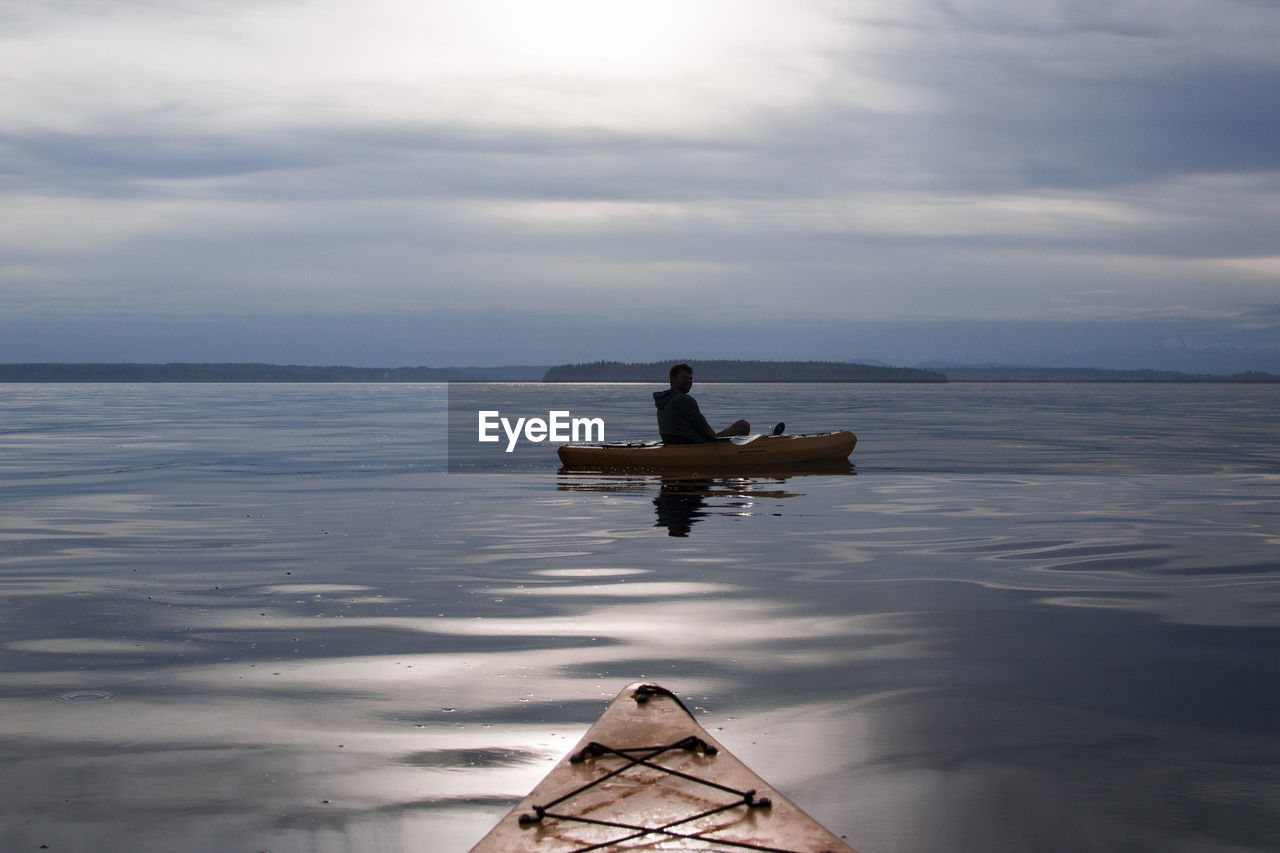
(557, 430, 858, 470)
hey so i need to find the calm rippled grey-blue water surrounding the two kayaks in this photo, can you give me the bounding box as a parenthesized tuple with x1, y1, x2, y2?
(0, 384, 1280, 853)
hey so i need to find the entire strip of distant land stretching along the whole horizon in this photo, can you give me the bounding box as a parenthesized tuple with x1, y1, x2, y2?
(0, 360, 1280, 384)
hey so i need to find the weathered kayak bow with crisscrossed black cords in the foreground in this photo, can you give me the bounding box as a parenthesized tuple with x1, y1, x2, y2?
(471, 684, 854, 853)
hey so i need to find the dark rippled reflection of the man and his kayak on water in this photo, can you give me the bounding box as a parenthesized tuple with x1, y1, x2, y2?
(557, 460, 856, 537)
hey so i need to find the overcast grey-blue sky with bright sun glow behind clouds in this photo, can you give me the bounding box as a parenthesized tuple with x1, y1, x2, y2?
(0, 0, 1280, 371)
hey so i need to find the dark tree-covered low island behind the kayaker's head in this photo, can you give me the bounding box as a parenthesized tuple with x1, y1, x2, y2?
(543, 359, 947, 383)
